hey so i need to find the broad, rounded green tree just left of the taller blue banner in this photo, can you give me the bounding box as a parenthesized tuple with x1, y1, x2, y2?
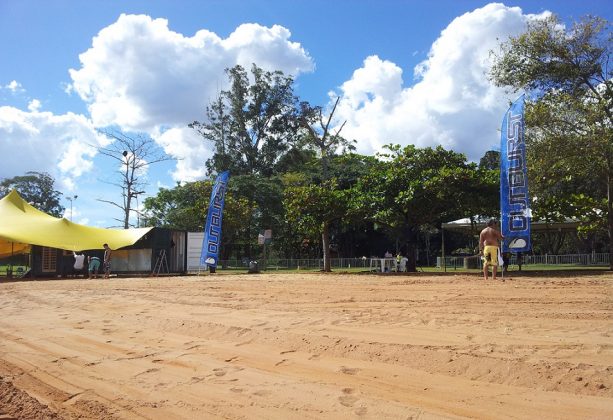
(351, 145, 499, 271)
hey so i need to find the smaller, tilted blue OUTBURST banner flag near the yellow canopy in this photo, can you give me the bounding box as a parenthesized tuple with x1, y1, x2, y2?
(200, 171, 230, 267)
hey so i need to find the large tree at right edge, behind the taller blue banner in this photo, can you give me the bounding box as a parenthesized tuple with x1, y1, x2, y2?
(491, 16, 613, 269)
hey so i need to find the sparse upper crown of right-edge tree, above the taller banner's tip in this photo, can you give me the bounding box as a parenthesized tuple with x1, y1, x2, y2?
(491, 15, 613, 103)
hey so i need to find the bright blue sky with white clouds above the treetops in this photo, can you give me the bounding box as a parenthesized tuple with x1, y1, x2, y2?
(0, 0, 613, 226)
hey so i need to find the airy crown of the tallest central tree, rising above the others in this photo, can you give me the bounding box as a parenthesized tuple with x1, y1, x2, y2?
(189, 64, 298, 176)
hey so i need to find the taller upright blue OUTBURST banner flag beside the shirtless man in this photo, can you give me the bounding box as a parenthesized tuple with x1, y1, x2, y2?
(500, 95, 531, 252)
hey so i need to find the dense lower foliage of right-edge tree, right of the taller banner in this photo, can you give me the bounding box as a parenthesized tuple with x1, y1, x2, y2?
(526, 93, 613, 230)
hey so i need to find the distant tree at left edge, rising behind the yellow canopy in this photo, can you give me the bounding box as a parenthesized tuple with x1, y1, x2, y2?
(0, 171, 64, 217)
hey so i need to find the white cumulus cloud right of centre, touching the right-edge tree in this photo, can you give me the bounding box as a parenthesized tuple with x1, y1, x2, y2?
(336, 3, 549, 160)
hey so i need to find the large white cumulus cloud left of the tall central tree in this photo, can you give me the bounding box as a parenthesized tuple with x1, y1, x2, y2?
(70, 14, 314, 180)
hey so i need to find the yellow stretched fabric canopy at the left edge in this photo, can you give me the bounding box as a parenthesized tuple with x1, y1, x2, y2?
(0, 190, 151, 251)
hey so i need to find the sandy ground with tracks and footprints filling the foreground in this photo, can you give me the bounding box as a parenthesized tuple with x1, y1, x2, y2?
(0, 273, 613, 419)
